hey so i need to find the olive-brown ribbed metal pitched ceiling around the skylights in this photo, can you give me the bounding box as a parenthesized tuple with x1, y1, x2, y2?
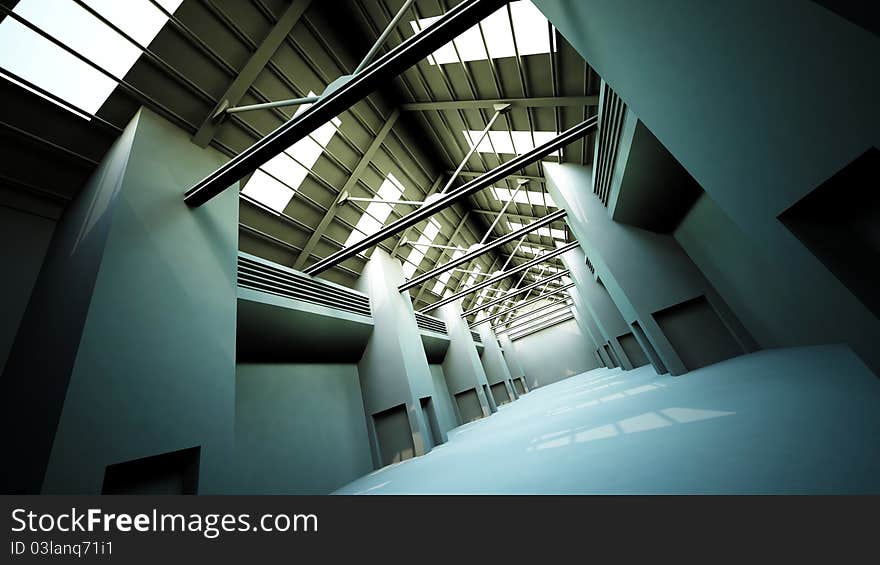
(0, 0, 600, 324)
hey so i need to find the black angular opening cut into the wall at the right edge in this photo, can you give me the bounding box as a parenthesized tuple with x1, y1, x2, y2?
(779, 147, 880, 317)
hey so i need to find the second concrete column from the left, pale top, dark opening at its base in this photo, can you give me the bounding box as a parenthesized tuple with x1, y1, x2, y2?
(356, 248, 435, 466)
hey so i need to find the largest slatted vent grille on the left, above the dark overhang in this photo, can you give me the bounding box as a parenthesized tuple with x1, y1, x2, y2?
(238, 254, 373, 317)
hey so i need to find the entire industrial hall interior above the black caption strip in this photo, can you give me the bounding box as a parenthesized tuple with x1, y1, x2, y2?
(0, 0, 880, 494)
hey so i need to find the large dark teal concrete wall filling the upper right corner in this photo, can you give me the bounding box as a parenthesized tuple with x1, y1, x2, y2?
(535, 0, 880, 372)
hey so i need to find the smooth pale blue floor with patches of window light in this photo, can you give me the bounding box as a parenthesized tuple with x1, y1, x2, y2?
(336, 346, 880, 494)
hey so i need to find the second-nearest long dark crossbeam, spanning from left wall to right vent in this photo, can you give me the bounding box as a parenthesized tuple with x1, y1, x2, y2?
(302, 115, 597, 275)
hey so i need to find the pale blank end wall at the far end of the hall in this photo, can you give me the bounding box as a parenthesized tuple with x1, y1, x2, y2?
(513, 320, 599, 389)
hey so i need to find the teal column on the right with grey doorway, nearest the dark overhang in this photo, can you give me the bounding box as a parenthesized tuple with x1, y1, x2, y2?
(545, 163, 757, 375)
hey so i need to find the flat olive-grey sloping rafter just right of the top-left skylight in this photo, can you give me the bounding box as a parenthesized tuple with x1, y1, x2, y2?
(193, 0, 312, 145)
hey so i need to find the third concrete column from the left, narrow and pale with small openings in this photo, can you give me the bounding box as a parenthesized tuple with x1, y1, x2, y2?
(440, 300, 495, 418)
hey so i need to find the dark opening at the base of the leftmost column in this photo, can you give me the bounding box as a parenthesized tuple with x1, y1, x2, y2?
(101, 446, 201, 494)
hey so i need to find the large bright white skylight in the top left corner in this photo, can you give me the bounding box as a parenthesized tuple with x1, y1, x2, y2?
(0, 0, 183, 114)
